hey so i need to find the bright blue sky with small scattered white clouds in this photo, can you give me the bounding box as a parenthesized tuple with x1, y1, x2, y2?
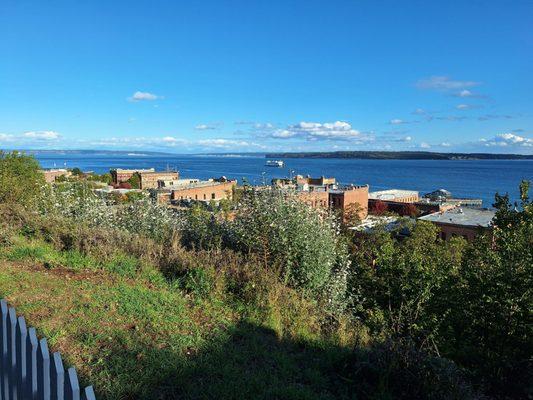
(0, 0, 533, 154)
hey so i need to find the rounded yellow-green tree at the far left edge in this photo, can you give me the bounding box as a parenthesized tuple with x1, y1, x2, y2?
(0, 151, 45, 207)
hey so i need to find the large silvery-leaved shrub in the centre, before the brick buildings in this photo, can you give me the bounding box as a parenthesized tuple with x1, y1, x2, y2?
(184, 191, 349, 311)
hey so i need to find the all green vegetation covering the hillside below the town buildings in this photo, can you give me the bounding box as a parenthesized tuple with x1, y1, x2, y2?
(0, 155, 533, 399)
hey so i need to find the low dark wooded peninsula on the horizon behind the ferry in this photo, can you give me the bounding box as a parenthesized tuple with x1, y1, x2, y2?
(265, 151, 533, 160)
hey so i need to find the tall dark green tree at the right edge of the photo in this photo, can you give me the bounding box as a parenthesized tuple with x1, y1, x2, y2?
(446, 181, 533, 398)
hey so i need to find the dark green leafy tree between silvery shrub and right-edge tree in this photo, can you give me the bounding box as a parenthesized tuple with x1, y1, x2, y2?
(349, 221, 467, 348)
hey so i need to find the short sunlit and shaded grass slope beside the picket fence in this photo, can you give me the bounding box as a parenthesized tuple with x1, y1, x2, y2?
(0, 236, 358, 399)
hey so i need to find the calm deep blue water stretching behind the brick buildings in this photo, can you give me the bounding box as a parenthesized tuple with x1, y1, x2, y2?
(36, 154, 533, 207)
